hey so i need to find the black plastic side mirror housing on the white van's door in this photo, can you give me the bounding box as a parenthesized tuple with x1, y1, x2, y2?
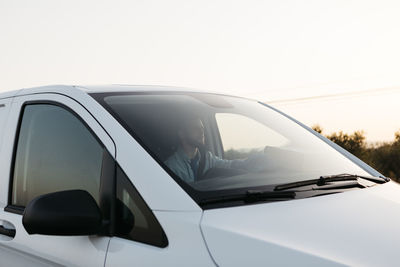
(22, 190, 102, 236)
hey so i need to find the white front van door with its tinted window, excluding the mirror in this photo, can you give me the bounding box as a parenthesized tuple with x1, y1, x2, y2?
(0, 94, 115, 266)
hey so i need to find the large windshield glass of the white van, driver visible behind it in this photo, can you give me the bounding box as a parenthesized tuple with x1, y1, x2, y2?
(93, 92, 369, 202)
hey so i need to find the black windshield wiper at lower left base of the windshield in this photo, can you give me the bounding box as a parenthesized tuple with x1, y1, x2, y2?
(199, 190, 296, 206)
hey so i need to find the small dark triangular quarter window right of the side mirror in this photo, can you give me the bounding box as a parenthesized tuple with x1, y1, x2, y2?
(116, 167, 168, 247)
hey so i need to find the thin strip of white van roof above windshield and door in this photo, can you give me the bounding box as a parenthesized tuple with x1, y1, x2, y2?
(0, 84, 222, 99)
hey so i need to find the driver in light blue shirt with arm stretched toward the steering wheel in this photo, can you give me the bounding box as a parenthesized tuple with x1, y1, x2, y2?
(164, 116, 246, 182)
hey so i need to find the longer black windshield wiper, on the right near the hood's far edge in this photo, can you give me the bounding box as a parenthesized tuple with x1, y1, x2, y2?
(274, 173, 390, 192)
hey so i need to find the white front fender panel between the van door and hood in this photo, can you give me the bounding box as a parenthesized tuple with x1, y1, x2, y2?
(106, 211, 215, 267)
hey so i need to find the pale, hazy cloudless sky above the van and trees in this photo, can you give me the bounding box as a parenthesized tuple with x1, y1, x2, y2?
(0, 0, 400, 142)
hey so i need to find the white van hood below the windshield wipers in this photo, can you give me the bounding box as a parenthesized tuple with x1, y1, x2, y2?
(201, 181, 400, 267)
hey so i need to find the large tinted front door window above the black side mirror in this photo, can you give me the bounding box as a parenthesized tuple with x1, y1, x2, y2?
(10, 104, 103, 207)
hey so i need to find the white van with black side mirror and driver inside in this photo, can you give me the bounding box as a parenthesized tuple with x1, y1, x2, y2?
(0, 86, 400, 267)
